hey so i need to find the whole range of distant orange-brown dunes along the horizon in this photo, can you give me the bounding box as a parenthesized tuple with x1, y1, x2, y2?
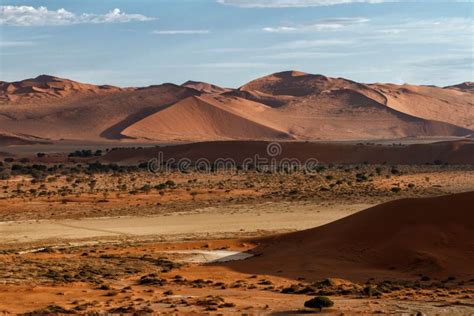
(0, 71, 474, 144)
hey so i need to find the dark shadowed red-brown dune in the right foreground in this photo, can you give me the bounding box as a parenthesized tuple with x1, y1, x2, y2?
(227, 192, 474, 281)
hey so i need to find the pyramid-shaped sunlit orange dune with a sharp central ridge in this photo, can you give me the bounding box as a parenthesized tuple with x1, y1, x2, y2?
(122, 97, 291, 140)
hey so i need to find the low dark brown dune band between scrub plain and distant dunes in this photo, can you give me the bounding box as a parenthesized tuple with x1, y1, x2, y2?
(101, 140, 474, 165)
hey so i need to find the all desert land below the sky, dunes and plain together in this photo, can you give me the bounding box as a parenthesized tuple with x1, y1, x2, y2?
(0, 71, 474, 315)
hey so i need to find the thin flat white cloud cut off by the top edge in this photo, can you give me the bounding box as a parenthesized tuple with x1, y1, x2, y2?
(217, 0, 390, 8)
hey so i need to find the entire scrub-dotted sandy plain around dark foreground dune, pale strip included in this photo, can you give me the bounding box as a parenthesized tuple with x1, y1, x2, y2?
(0, 165, 474, 315)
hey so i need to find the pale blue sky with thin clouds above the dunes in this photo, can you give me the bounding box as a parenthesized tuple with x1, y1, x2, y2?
(0, 0, 474, 88)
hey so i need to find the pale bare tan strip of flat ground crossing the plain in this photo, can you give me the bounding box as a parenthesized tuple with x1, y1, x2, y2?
(0, 202, 371, 245)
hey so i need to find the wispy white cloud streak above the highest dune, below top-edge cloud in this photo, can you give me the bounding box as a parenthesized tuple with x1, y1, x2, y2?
(262, 18, 370, 33)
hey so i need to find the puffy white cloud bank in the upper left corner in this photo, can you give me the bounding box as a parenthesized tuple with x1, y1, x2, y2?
(0, 6, 153, 26)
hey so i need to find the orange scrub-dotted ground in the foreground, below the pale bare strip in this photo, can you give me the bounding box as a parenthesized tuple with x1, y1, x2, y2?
(0, 240, 474, 315)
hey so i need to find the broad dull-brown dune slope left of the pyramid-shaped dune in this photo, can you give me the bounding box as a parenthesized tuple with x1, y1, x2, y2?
(0, 79, 199, 141)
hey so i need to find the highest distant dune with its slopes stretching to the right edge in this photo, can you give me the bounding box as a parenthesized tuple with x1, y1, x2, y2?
(234, 71, 474, 135)
